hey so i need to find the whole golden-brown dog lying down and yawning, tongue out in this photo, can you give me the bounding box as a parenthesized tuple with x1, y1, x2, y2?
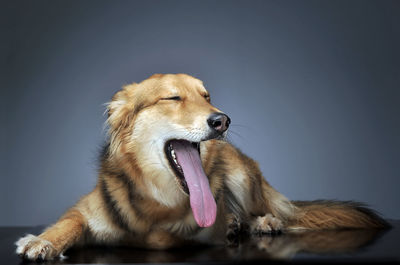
(16, 74, 388, 260)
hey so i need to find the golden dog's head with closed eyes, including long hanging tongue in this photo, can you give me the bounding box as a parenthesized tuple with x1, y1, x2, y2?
(108, 74, 230, 226)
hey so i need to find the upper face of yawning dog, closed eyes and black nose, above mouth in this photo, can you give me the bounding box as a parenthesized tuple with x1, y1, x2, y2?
(133, 74, 229, 143)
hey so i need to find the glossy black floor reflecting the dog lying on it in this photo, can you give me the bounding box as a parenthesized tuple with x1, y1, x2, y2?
(0, 221, 400, 264)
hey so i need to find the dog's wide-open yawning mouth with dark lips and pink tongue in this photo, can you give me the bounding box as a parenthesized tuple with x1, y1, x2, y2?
(165, 140, 217, 227)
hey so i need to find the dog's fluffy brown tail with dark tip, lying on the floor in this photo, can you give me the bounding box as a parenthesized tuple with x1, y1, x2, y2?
(288, 200, 390, 230)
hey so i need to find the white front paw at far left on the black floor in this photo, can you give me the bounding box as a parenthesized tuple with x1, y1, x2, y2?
(15, 235, 59, 260)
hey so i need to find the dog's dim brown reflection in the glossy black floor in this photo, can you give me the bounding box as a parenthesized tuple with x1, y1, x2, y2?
(66, 225, 390, 263)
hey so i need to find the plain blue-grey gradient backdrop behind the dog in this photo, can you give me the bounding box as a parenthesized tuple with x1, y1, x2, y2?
(0, 0, 400, 225)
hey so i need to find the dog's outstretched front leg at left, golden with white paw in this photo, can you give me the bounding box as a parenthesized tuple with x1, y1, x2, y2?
(16, 209, 86, 260)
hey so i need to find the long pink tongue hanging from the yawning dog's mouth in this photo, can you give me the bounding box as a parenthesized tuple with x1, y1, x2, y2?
(171, 140, 217, 227)
